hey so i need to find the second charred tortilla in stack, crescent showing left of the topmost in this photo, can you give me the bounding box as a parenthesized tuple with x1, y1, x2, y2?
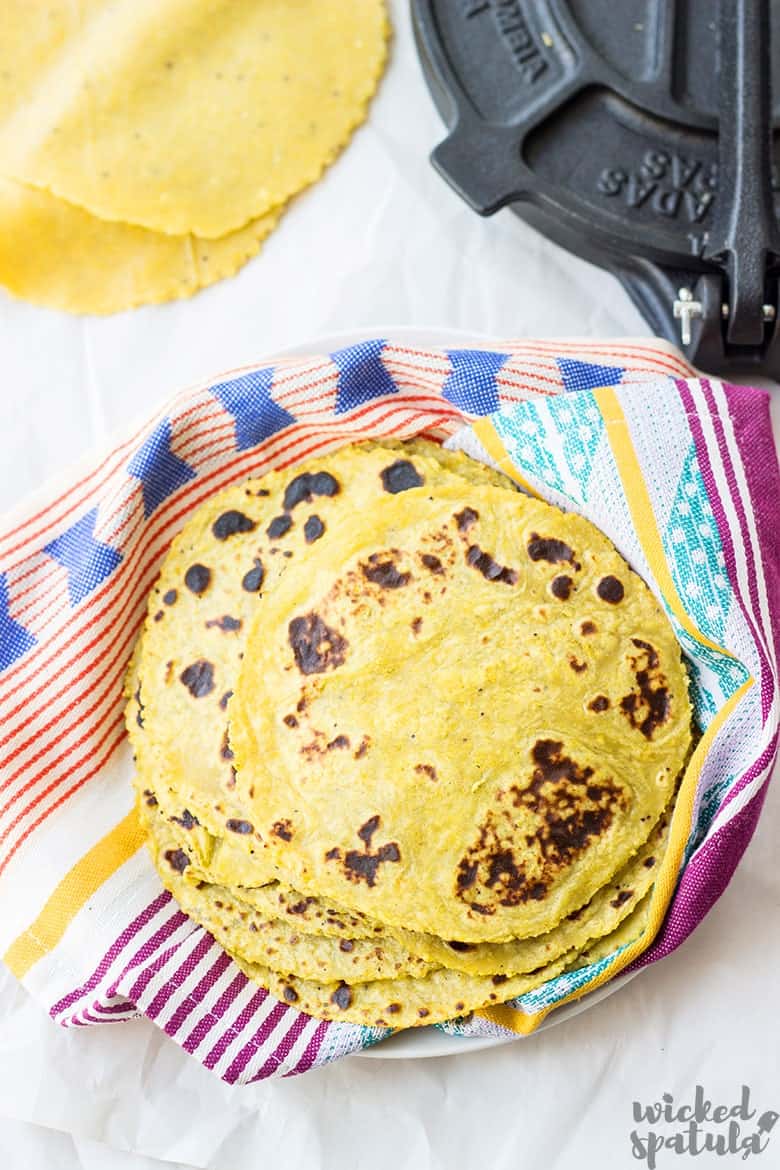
(126, 440, 515, 883)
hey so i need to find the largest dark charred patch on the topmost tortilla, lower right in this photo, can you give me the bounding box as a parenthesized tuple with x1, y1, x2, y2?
(455, 739, 626, 915)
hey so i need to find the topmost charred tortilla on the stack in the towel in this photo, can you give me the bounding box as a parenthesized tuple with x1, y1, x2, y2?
(229, 481, 691, 943)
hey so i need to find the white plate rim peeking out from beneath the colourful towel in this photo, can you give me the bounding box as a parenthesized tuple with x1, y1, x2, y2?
(256, 325, 639, 1060)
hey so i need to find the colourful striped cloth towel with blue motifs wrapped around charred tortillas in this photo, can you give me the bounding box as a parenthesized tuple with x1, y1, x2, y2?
(0, 339, 780, 1083)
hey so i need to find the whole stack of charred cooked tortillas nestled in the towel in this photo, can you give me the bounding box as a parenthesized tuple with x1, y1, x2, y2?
(127, 440, 691, 1027)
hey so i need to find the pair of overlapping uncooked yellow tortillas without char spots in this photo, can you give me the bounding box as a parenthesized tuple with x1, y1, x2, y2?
(0, 0, 388, 314)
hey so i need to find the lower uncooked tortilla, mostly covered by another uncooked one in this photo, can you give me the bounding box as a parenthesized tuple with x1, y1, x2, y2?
(0, 178, 281, 314)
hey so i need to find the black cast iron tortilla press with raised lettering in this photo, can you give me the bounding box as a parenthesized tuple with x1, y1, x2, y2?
(412, 0, 780, 379)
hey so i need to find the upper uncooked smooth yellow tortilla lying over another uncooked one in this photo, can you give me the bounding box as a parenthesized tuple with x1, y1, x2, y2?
(0, 0, 388, 239)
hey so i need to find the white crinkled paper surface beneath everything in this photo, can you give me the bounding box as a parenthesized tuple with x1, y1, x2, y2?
(0, 0, 780, 1170)
